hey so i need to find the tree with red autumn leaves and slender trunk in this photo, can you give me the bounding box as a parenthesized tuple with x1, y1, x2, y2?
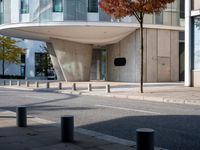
(99, 0, 175, 93)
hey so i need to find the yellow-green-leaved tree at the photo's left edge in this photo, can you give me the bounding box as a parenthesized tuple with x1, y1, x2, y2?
(0, 36, 26, 76)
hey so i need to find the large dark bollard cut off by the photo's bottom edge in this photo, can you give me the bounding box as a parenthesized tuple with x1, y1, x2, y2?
(136, 128, 154, 150)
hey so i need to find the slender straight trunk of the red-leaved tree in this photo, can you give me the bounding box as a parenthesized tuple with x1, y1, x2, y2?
(140, 17, 144, 93)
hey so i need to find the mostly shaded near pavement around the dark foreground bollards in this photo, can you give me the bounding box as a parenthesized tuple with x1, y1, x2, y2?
(0, 110, 138, 150)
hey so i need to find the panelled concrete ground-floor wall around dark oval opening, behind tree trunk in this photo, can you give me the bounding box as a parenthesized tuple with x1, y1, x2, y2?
(107, 29, 179, 82)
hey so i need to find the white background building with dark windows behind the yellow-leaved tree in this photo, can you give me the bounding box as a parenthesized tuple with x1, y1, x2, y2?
(0, 39, 55, 79)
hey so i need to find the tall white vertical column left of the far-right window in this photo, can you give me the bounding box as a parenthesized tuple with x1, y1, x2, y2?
(185, 0, 192, 86)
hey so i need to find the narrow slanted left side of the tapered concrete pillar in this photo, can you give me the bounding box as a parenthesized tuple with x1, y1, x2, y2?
(46, 43, 65, 81)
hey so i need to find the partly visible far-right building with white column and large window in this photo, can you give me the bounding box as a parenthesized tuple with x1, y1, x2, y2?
(185, 0, 200, 87)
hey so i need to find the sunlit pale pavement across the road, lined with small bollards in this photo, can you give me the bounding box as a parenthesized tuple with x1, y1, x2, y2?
(0, 80, 200, 105)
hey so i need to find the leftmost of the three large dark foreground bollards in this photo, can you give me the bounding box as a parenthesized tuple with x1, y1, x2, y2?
(16, 106, 27, 127)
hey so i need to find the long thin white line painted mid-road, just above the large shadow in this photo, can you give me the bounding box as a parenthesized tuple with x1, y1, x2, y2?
(95, 105, 161, 115)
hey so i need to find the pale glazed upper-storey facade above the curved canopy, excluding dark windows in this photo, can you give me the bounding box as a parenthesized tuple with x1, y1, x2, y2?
(0, 0, 180, 26)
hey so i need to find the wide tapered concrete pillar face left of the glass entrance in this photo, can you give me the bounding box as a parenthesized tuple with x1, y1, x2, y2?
(51, 39, 92, 82)
